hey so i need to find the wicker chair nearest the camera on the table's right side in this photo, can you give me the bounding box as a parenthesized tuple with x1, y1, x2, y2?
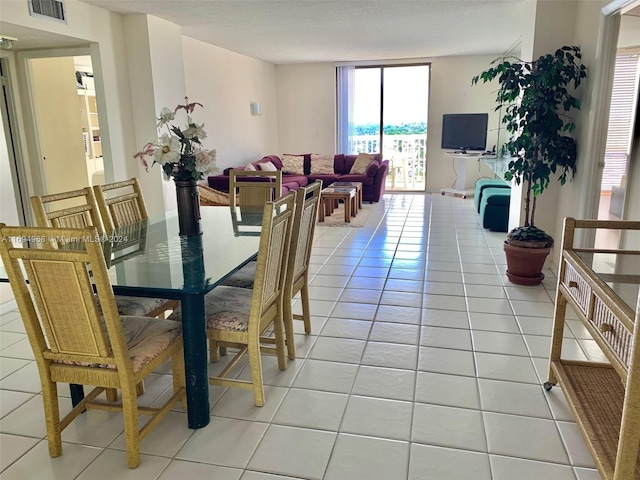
(169, 192, 296, 407)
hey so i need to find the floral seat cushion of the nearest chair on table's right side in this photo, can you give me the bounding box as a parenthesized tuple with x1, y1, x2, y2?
(169, 285, 253, 332)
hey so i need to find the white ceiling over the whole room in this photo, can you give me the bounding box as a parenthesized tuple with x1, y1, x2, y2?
(0, 0, 525, 64)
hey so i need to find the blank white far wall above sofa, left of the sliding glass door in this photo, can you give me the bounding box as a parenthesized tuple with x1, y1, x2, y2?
(276, 63, 341, 154)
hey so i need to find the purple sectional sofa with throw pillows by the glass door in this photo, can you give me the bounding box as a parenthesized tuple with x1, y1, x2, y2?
(207, 154, 389, 202)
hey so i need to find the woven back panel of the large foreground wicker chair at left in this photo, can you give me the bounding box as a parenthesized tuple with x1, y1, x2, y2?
(0, 224, 128, 365)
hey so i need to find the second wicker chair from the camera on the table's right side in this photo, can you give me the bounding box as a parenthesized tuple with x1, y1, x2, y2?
(222, 180, 322, 360)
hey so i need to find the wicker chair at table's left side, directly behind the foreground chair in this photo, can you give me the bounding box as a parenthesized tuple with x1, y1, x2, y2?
(31, 187, 179, 317)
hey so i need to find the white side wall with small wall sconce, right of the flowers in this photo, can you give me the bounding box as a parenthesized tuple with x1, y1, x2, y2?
(182, 37, 278, 173)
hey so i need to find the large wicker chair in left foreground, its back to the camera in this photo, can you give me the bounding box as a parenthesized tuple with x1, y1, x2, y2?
(0, 224, 185, 468)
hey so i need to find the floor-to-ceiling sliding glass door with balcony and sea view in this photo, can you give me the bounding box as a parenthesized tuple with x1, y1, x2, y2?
(337, 64, 430, 190)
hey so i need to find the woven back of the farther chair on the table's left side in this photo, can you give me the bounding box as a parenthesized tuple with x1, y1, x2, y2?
(93, 178, 149, 231)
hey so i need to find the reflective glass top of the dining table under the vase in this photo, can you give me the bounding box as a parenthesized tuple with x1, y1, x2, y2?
(98, 206, 262, 294)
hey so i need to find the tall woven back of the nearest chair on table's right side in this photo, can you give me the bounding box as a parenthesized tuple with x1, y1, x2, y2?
(249, 192, 296, 329)
